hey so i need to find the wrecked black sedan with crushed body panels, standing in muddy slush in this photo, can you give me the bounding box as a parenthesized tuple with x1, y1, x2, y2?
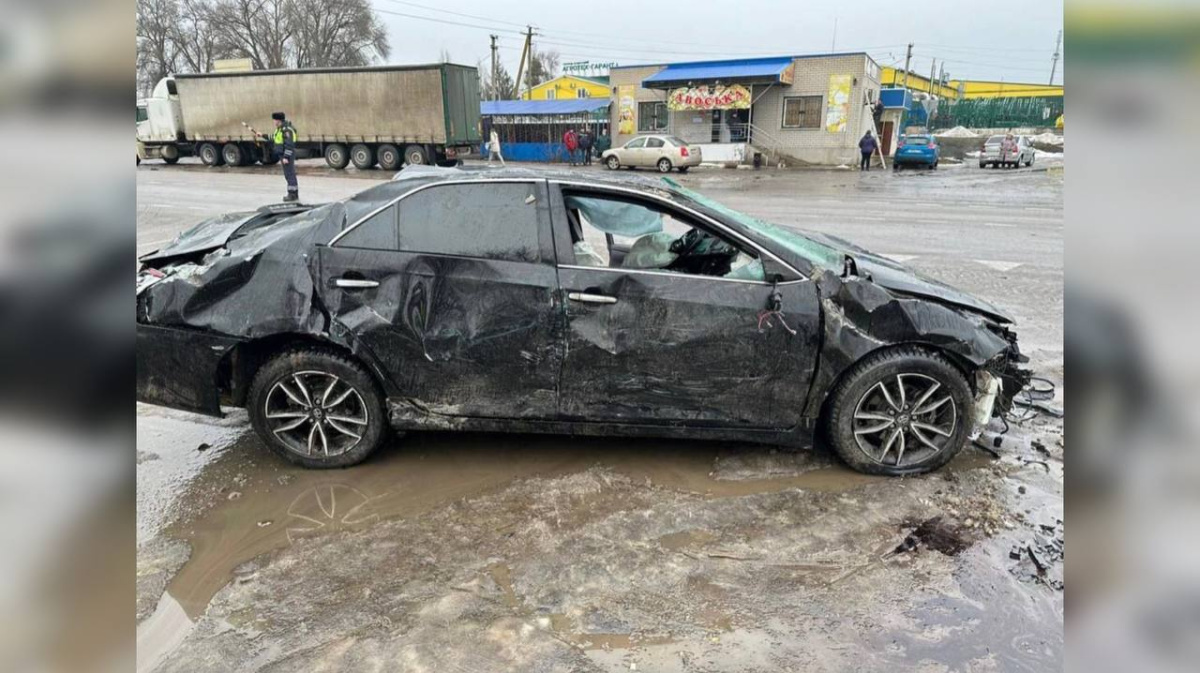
(137, 168, 1027, 474)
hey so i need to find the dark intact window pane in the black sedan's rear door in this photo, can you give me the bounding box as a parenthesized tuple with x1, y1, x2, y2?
(398, 182, 540, 262)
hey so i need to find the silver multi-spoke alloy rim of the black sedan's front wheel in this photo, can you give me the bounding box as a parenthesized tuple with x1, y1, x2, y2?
(854, 373, 959, 468)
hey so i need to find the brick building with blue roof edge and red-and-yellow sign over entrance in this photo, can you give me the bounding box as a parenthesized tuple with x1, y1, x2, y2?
(610, 52, 880, 164)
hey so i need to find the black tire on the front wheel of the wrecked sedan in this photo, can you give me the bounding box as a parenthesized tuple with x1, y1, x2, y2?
(826, 347, 974, 476)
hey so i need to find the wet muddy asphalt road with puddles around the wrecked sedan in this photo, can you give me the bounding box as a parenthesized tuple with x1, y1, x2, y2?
(137, 162, 1063, 671)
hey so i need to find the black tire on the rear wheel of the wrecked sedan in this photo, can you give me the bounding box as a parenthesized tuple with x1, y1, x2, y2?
(246, 348, 388, 469)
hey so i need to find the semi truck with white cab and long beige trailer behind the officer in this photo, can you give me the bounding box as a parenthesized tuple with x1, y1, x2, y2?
(137, 64, 480, 170)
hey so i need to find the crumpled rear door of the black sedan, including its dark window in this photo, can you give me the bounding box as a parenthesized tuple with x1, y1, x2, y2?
(320, 180, 562, 419)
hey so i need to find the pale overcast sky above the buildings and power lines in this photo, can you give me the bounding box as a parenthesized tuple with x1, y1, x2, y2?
(368, 0, 1062, 83)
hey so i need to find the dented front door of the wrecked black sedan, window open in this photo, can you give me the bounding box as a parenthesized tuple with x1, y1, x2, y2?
(551, 184, 820, 428)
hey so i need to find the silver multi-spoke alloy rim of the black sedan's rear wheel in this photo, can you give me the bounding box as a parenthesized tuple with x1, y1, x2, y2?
(263, 371, 371, 457)
